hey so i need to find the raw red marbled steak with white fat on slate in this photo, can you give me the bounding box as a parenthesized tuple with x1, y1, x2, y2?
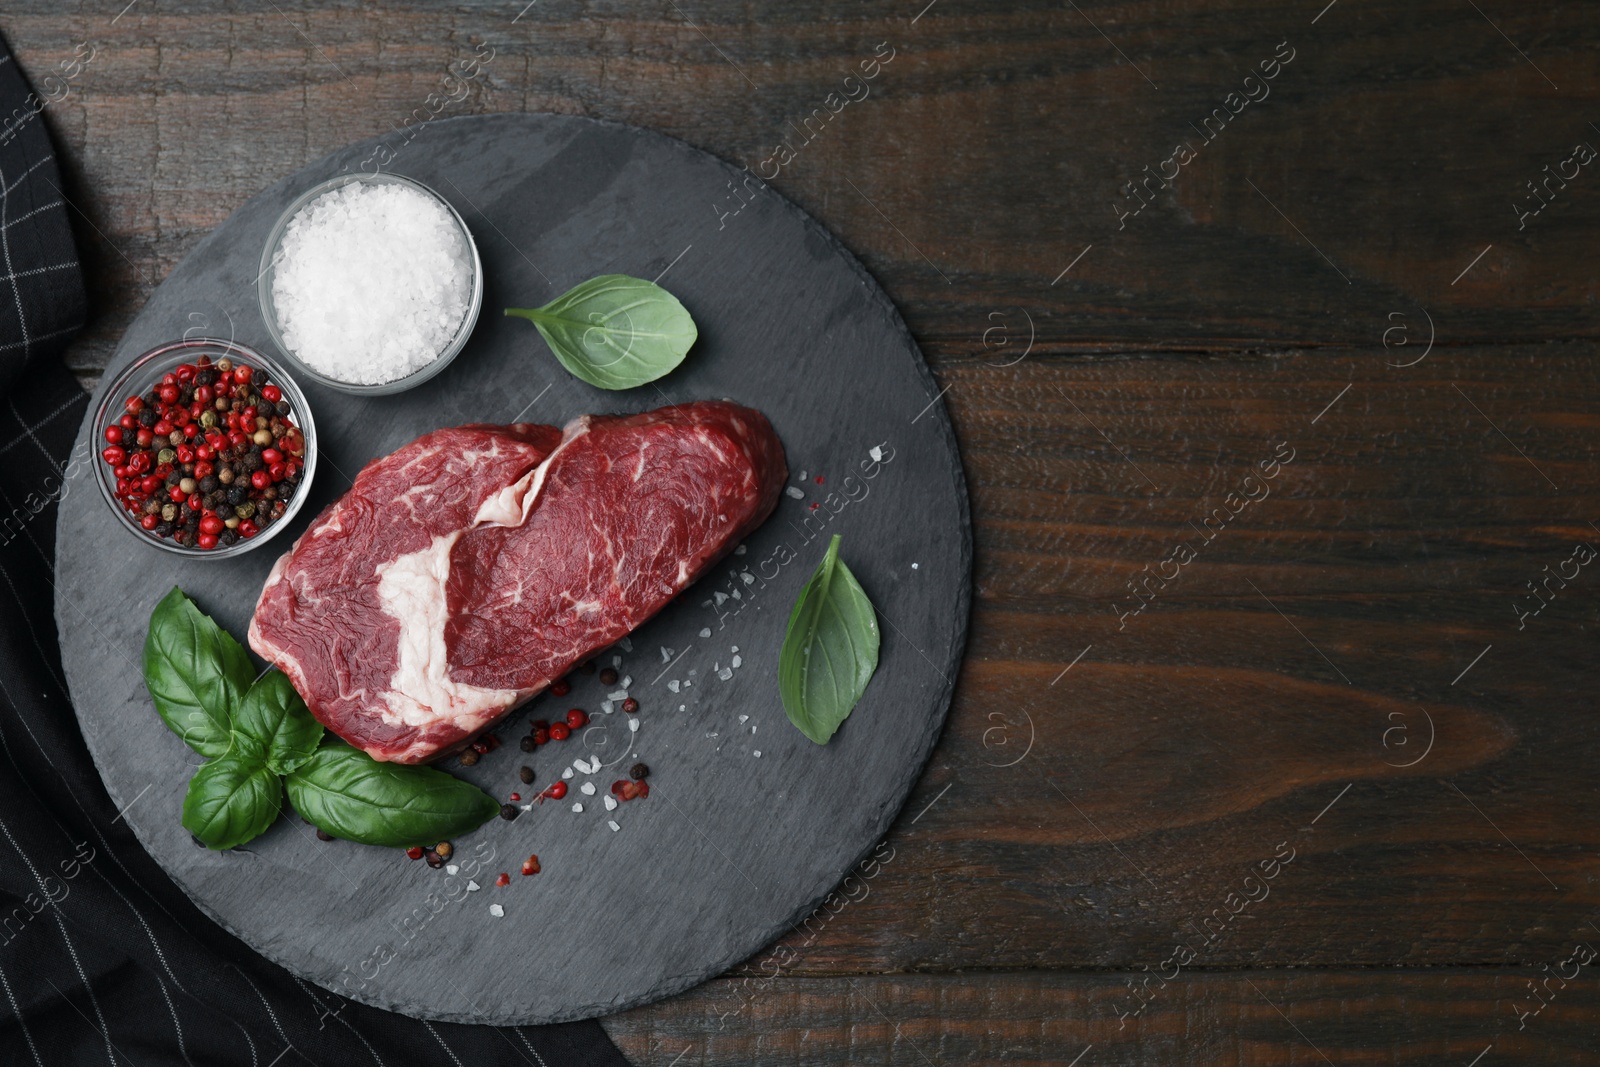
(250, 402, 787, 763)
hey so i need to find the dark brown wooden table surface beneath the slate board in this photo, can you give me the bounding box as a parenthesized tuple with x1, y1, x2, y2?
(0, 0, 1600, 1067)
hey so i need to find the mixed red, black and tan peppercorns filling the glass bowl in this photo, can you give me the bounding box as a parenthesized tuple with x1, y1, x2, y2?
(101, 355, 306, 549)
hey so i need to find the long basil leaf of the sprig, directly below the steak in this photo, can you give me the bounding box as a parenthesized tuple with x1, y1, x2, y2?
(285, 742, 499, 848)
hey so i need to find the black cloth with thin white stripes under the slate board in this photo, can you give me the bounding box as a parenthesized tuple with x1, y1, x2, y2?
(0, 33, 627, 1067)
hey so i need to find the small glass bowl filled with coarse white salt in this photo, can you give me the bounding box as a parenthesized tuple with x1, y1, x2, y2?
(258, 173, 483, 395)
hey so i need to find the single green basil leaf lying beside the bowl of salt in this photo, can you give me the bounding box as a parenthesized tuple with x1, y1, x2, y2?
(506, 274, 698, 389)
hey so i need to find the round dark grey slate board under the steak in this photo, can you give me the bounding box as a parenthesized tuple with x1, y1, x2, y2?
(56, 115, 971, 1024)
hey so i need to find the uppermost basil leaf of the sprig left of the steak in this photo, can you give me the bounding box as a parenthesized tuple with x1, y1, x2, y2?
(144, 585, 256, 758)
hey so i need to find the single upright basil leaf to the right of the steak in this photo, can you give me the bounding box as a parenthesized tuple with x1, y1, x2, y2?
(778, 534, 878, 745)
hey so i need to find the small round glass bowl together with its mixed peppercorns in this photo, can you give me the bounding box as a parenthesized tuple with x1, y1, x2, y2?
(94, 338, 317, 558)
